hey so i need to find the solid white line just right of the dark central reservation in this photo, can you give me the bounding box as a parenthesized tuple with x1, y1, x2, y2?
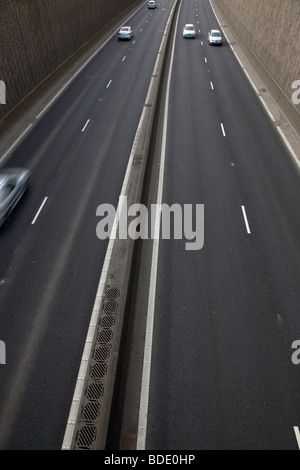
(136, 3, 182, 450)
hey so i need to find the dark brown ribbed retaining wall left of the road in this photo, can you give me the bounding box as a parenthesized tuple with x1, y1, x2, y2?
(0, 0, 142, 119)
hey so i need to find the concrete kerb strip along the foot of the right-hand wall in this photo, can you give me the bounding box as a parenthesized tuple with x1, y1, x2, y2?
(209, 0, 300, 170)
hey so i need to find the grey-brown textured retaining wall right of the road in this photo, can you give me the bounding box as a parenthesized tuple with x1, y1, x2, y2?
(213, 0, 300, 132)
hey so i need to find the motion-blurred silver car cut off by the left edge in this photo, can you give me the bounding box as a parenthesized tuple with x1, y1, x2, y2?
(0, 168, 30, 227)
